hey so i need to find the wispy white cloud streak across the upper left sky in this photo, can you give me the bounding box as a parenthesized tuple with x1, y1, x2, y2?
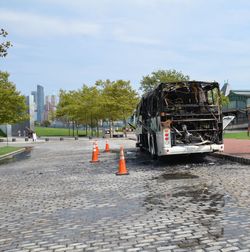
(0, 9, 100, 37)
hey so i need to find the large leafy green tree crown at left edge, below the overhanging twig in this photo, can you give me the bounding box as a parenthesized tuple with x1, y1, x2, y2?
(0, 71, 28, 124)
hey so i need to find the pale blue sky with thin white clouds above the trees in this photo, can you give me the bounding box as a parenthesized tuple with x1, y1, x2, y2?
(0, 0, 250, 95)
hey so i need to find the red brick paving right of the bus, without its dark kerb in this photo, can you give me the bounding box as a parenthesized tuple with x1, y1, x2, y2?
(224, 139, 250, 159)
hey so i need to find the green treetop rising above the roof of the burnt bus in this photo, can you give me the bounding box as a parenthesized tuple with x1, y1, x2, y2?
(140, 69, 189, 92)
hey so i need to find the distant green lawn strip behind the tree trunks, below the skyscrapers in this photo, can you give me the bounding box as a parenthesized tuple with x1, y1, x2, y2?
(35, 127, 89, 136)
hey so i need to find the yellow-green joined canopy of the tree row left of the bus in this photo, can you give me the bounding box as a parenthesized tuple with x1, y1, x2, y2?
(57, 80, 139, 126)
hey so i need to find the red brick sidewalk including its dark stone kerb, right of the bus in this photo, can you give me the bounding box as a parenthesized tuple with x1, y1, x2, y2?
(214, 139, 250, 164)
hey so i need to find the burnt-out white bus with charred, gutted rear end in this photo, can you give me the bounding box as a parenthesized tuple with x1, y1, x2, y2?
(136, 81, 224, 156)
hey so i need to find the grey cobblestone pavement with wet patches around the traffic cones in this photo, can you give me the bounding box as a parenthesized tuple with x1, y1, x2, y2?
(0, 139, 250, 252)
